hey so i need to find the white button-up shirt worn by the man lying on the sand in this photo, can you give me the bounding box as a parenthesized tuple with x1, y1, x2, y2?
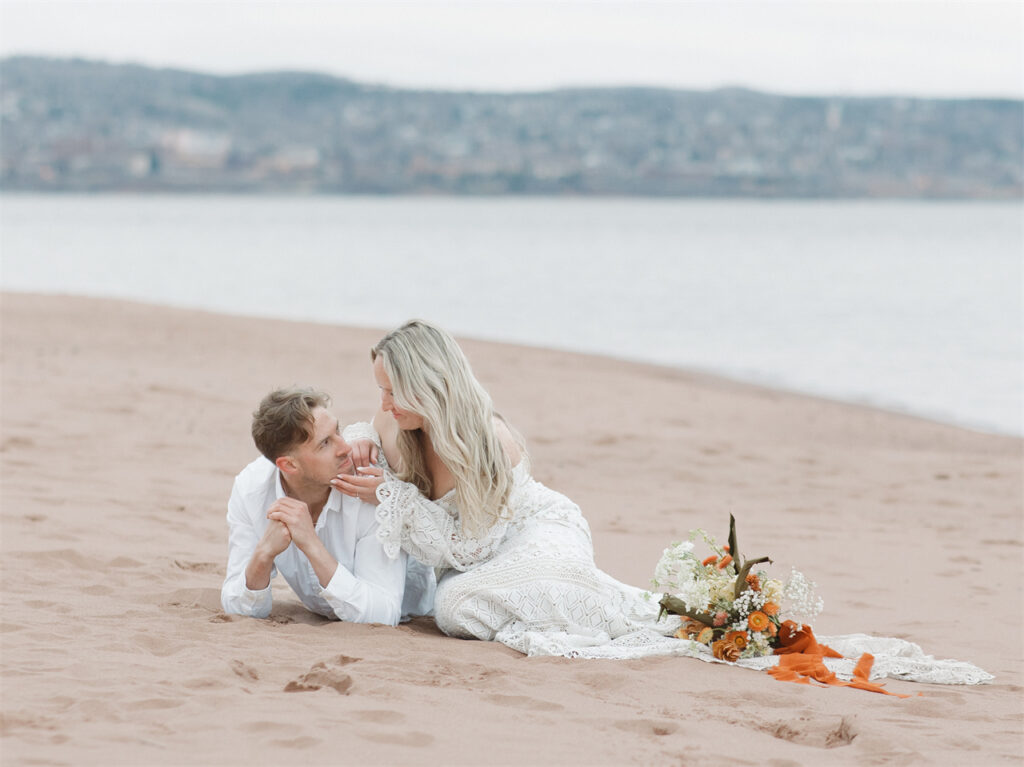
(220, 457, 436, 626)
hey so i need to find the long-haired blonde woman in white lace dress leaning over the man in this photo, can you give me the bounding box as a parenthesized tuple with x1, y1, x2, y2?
(335, 321, 686, 657)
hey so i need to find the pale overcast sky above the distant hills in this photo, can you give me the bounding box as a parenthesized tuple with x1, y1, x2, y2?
(0, 0, 1024, 98)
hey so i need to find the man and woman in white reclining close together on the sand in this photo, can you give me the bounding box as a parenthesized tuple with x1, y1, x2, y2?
(221, 321, 663, 655)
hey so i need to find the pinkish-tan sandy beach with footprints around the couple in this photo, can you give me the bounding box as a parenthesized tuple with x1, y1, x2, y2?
(0, 294, 1024, 767)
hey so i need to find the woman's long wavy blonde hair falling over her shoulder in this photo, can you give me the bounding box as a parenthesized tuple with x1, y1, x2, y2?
(370, 319, 512, 535)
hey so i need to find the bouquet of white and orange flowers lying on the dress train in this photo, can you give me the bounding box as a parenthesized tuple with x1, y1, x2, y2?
(651, 514, 823, 662)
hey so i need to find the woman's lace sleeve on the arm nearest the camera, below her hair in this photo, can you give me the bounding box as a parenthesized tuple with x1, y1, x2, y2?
(377, 477, 508, 570)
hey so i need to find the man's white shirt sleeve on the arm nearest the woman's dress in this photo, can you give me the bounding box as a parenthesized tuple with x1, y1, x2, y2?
(321, 507, 407, 626)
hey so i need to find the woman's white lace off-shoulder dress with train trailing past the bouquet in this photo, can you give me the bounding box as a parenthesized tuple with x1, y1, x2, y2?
(345, 423, 992, 684)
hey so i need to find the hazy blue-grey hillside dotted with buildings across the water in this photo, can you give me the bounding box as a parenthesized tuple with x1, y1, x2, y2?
(0, 57, 1024, 198)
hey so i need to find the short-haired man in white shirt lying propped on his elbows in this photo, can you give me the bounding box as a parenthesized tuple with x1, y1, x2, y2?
(220, 388, 435, 626)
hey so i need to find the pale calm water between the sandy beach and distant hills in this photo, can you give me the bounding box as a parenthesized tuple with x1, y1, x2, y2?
(0, 196, 1024, 434)
